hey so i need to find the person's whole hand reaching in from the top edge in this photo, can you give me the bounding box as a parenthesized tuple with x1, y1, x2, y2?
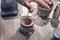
(18, 0, 51, 12)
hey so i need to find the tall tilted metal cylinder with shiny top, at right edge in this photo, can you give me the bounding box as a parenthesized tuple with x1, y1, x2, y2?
(51, 2, 60, 27)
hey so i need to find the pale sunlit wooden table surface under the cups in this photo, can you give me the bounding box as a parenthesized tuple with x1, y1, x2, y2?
(0, 0, 60, 40)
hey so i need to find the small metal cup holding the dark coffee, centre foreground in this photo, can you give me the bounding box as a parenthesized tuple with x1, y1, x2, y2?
(20, 16, 34, 37)
